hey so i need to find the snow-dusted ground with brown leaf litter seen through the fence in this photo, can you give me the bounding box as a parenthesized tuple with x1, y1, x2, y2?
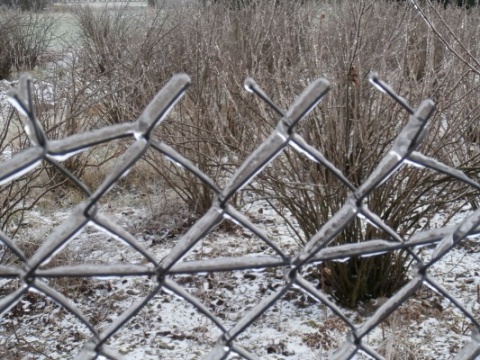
(0, 184, 480, 359)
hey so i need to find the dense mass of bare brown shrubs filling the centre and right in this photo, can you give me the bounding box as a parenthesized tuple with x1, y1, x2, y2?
(0, 0, 480, 307)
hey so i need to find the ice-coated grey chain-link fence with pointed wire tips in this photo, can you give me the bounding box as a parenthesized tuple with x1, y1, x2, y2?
(0, 74, 480, 360)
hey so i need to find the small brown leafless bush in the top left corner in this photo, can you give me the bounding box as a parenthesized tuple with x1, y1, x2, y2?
(0, 7, 56, 80)
